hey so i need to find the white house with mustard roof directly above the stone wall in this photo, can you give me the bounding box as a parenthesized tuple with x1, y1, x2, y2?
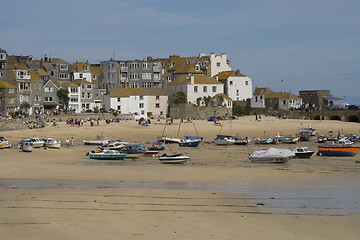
(167, 75, 224, 105)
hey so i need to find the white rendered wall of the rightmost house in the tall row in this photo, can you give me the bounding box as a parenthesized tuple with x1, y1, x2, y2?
(227, 77, 253, 101)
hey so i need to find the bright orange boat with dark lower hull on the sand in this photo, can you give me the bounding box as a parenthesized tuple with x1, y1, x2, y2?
(317, 144, 359, 157)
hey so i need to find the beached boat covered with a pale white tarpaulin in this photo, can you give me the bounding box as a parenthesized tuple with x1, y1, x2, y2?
(249, 148, 295, 163)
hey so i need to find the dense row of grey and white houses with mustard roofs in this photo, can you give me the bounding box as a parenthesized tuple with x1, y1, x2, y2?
(0, 49, 252, 117)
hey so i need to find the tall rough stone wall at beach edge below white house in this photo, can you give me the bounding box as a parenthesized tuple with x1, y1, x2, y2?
(169, 103, 232, 120)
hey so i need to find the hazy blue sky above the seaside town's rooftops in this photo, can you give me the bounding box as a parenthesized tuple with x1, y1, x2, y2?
(0, 0, 360, 104)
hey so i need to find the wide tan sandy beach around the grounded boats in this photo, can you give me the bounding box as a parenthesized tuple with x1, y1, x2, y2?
(0, 116, 360, 239)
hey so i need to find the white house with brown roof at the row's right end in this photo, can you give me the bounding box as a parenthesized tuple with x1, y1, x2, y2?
(215, 70, 252, 101)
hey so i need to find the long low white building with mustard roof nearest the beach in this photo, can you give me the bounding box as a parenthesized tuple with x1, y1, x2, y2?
(103, 88, 168, 118)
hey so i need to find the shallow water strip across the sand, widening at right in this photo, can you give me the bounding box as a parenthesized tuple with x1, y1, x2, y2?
(0, 176, 360, 215)
